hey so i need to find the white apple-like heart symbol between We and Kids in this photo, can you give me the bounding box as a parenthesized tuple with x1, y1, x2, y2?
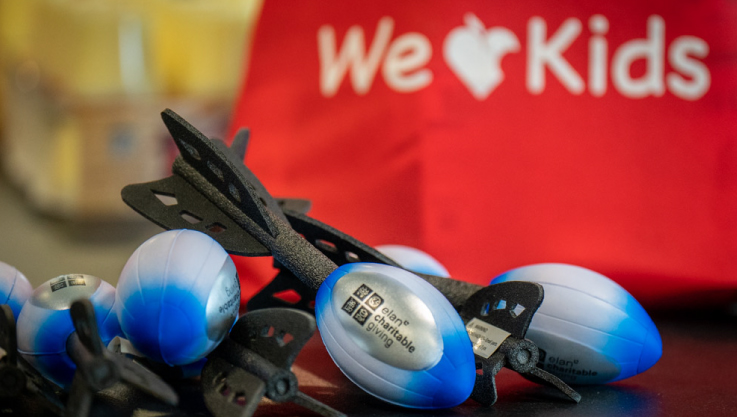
(443, 13, 520, 100)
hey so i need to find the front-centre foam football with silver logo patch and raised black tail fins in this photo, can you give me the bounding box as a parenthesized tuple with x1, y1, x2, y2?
(122, 110, 578, 408)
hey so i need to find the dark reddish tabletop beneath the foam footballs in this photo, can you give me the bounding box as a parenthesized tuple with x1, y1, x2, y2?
(7, 311, 737, 417)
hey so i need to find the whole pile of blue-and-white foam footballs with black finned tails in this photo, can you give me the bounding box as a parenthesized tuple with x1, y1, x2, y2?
(0, 110, 662, 416)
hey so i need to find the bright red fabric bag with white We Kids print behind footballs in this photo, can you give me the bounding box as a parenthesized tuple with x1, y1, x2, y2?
(232, 0, 737, 305)
